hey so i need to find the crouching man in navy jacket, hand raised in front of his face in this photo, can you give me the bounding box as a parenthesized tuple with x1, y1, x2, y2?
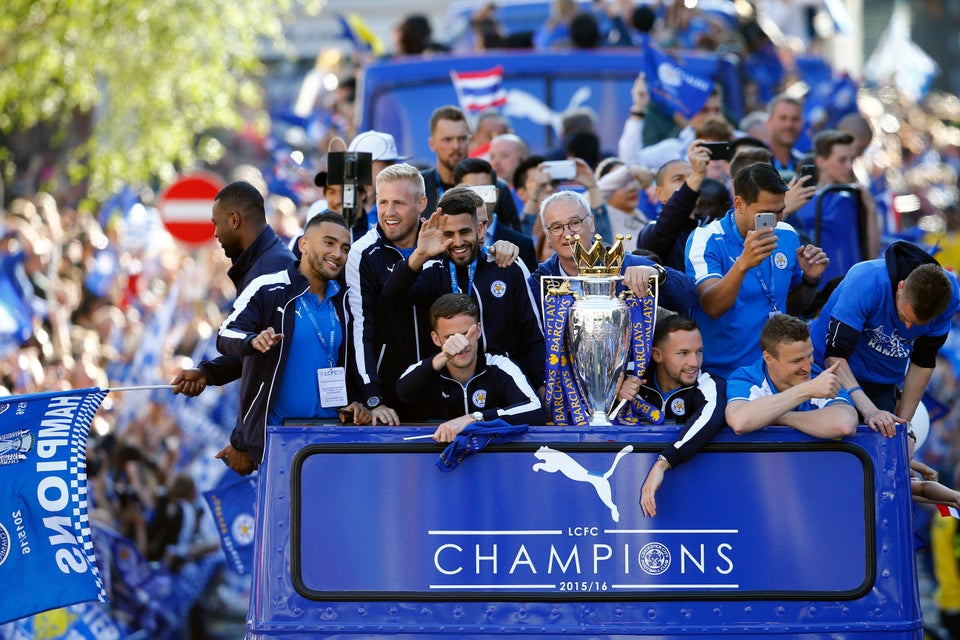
(397, 293, 546, 442)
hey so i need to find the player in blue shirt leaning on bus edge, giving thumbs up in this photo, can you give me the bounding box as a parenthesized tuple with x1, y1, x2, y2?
(726, 314, 857, 438)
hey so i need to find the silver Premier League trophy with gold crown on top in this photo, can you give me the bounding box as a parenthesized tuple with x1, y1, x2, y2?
(567, 235, 630, 425)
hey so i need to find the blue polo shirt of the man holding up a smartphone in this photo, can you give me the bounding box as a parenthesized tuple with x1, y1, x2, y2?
(686, 209, 803, 378)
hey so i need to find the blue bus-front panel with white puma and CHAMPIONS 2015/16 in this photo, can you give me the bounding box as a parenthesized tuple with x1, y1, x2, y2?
(290, 442, 875, 600)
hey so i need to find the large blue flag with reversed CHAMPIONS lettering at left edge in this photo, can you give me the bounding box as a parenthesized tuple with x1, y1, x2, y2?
(0, 388, 107, 623)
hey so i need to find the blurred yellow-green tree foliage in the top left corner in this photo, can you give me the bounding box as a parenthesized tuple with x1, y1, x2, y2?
(0, 0, 316, 197)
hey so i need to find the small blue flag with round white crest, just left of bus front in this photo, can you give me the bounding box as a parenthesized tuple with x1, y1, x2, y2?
(203, 472, 257, 575)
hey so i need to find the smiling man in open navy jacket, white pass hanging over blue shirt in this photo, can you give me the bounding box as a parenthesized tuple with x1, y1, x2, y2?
(217, 213, 368, 473)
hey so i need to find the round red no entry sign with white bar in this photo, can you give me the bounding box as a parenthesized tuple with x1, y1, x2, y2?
(157, 173, 224, 245)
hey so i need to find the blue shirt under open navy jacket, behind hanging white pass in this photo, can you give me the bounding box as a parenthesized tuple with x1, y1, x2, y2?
(267, 281, 343, 424)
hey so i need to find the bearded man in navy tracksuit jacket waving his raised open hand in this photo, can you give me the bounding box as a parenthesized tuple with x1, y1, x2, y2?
(383, 187, 545, 389)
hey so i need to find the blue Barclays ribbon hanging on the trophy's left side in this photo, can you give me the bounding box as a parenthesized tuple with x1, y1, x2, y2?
(543, 278, 589, 426)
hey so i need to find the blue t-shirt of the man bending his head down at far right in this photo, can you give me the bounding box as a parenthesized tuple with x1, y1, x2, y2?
(810, 258, 960, 384)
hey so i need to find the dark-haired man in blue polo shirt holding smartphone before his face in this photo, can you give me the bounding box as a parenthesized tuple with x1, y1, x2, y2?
(686, 163, 830, 377)
